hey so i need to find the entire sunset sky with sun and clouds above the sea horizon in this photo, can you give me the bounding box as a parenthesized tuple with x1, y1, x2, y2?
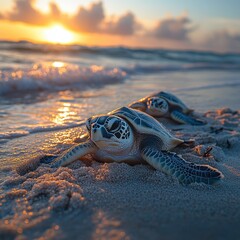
(0, 0, 240, 53)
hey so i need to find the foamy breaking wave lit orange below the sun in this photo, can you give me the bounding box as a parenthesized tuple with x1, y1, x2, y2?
(0, 62, 126, 94)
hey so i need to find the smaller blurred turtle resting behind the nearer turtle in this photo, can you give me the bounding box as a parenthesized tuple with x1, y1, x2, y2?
(129, 91, 205, 125)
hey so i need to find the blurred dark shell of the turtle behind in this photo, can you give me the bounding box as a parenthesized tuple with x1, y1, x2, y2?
(150, 91, 193, 113)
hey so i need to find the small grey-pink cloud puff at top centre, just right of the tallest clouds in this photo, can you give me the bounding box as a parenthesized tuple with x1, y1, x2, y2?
(105, 12, 141, 35)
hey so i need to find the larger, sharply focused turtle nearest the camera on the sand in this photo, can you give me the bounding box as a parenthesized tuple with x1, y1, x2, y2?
(51, 107, 223, 184)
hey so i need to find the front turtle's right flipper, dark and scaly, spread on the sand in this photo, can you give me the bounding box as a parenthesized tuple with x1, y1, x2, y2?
(141, 147, 223, 185)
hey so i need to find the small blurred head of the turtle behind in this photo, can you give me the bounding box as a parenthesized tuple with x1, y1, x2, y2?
(146, 97, 169, 117)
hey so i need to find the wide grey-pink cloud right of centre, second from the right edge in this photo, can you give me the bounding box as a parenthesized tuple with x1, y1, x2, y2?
(150, 16, 193, 41)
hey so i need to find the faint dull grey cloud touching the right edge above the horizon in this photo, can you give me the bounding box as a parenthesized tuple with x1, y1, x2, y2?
(203, 29, 240, 52)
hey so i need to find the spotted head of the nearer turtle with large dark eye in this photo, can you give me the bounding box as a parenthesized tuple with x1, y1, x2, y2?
(86, 115, 134, 153)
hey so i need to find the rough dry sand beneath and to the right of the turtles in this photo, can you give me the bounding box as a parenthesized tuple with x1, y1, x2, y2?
(0, 109, 240, 240)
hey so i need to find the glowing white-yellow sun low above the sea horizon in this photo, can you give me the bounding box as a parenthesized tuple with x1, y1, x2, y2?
(43, 24, 74, 43)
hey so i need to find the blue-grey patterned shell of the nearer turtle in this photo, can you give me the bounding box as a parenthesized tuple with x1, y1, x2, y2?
(108, 107, 183, 150)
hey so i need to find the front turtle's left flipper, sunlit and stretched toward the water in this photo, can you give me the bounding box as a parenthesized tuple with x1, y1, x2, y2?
(50, 141, 98, 167)
